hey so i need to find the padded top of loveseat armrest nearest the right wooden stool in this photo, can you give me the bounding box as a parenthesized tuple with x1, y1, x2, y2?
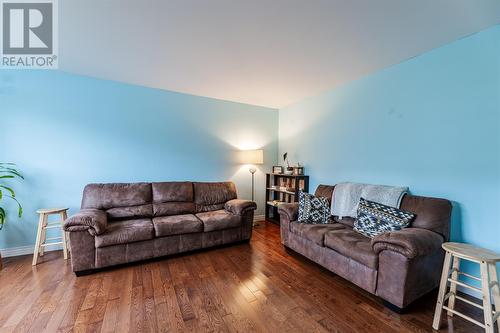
(371, 228, 444, 259)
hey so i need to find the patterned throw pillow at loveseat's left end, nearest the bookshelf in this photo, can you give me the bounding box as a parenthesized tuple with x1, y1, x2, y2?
(299, 191, 330, 224)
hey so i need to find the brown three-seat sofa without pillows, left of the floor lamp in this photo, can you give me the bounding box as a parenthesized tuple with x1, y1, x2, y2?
(64, 182, 257, 275)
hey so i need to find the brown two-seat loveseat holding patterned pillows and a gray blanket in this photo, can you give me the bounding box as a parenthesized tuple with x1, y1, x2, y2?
(279, 185, 451, 311)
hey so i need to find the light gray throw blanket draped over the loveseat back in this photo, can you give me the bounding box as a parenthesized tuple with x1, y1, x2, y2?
(332, 183, 408, 218)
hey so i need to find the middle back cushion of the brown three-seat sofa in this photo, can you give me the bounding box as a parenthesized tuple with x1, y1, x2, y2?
(152, 182, 195, 216)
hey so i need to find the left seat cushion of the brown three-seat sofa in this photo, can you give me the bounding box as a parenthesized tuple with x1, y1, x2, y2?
(95, 219, 154, 247)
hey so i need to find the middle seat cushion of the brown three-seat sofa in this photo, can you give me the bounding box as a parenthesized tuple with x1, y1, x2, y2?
(153, 214, 203, 237)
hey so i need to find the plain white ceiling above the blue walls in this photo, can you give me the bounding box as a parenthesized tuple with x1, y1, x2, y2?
(59, 0, 500, 108)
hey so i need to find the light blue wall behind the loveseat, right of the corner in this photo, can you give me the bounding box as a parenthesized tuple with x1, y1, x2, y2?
(279, 26, 500, 280)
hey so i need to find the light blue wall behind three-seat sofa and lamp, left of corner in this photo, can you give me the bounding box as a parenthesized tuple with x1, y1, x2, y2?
(0, 70, 278, 249)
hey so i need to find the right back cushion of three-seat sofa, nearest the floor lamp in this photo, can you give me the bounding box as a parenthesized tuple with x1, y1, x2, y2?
(193, 182, 237, 212)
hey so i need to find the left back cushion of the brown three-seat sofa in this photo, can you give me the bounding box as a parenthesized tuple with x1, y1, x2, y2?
(82, 183, 153, 219)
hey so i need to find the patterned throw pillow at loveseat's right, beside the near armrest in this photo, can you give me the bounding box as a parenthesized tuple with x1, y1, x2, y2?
(354, 198, 415, 237)
